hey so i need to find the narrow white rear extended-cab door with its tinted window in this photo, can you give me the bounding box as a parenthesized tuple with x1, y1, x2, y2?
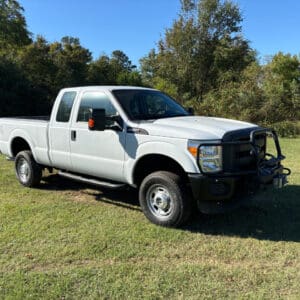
(49, 91, 77, 170)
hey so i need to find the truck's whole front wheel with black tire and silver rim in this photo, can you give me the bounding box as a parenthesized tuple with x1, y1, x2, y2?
(139, 171, 191, 227)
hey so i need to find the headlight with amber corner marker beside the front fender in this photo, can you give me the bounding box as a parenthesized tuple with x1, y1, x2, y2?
(188, 141, 222, 173)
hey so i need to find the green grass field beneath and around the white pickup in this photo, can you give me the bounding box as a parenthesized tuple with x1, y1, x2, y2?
(0, 139, 300, 299)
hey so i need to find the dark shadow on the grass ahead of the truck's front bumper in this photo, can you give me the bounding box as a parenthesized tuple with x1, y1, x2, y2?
(184, 185, 300, 242)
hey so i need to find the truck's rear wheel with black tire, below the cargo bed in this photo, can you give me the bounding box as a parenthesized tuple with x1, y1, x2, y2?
(15, 150, 42, 187)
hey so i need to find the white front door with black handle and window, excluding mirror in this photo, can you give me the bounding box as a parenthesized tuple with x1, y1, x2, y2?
(70, 91, 125, 181)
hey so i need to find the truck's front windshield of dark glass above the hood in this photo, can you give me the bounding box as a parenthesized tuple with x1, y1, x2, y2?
(112, 89, 189, 120)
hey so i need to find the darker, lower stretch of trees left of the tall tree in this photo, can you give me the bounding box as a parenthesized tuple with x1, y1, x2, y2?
(0, 0, 142, 116)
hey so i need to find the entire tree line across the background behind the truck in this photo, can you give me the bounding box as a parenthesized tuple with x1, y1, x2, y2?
(0, 0, 300, 133)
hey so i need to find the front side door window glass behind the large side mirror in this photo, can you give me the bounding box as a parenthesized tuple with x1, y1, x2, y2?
(77, 92, 117, 122)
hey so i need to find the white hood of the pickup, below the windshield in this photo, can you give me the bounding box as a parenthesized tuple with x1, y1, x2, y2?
(140, 116, 257, 140)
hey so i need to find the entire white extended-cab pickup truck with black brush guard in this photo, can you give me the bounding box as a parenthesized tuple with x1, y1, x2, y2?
(0, 86, 290, 226)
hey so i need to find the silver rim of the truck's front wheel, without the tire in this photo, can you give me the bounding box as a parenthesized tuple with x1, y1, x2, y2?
(146, 184, 174, 219)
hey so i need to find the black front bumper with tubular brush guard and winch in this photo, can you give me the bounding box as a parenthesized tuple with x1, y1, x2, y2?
(188, 129, 291, 213)
